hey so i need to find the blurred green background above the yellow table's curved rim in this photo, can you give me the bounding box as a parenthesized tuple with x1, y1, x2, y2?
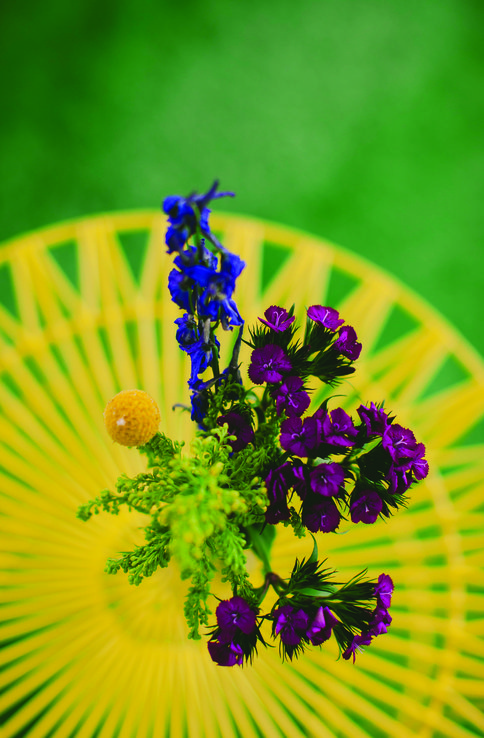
(0, 0, 484, 353)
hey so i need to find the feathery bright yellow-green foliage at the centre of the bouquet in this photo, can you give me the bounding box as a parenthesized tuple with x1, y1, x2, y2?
(77, 427, 268, 638)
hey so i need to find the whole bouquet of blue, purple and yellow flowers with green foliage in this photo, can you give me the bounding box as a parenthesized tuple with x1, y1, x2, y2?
(78, 182, 428, 666)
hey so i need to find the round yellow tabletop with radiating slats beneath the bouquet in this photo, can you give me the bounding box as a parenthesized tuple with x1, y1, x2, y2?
(0, 212, 484, 738)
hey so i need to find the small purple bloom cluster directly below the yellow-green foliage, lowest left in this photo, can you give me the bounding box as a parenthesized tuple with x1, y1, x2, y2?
(207, 595, 260, 666)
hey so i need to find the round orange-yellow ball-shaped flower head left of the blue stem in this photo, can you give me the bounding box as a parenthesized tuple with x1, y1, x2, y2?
(104, 390, 161, 446)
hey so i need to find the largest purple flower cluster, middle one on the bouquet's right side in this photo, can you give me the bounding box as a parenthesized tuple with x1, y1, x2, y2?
(265, 396, 428, 533)
